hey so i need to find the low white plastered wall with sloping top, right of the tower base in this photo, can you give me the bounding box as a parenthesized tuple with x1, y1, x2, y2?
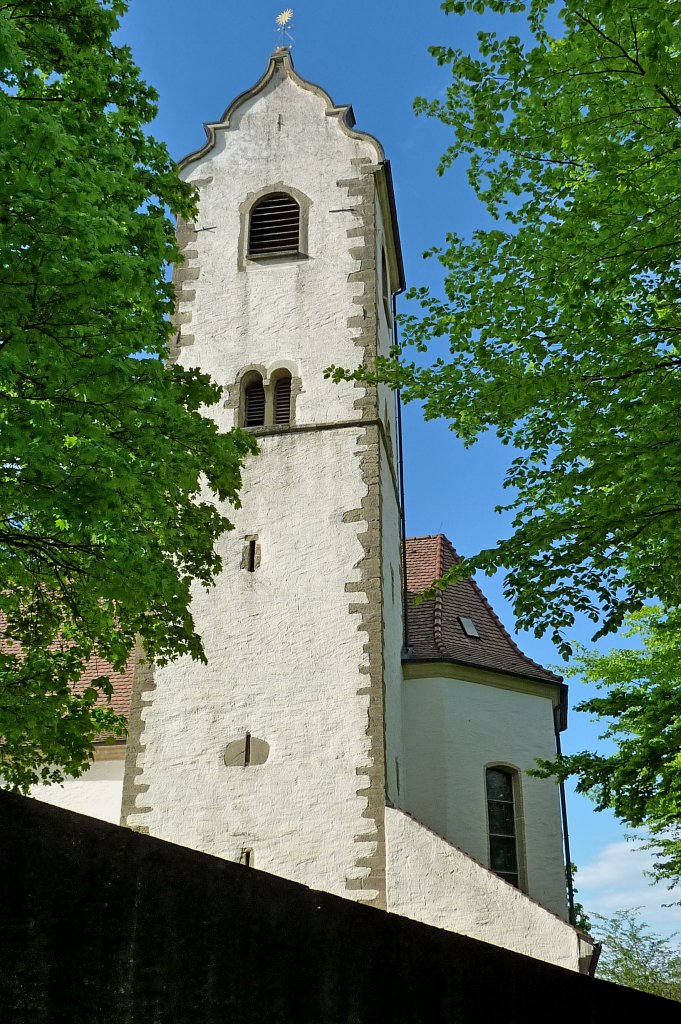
(385, 807, 591, 971)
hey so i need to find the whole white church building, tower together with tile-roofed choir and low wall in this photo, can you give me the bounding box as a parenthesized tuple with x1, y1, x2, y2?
(109, 49, 592, 971)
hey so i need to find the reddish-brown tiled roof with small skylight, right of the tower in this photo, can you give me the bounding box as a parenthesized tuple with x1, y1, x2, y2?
(407, 534, 561, 683)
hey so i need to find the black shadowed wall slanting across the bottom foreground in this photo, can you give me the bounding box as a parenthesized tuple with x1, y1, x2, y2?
(0, 793, 679, 1024)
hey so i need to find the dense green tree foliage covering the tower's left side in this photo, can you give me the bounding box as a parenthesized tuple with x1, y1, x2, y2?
(0, 0, 254, 788)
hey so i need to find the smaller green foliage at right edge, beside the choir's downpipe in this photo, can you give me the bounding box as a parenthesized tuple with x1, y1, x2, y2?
(541, 607, 681, 885)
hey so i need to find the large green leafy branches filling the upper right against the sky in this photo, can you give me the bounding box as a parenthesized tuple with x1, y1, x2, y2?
(337, 0, 681, 654)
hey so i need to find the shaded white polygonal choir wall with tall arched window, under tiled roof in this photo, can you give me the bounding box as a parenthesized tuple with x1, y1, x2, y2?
(400, 670, 566, 918)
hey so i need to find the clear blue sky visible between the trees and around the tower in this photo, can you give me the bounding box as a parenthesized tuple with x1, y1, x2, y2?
(119, 0, 681, 932)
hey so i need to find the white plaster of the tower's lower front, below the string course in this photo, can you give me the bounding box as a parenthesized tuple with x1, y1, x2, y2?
(128, 428, 385, 894)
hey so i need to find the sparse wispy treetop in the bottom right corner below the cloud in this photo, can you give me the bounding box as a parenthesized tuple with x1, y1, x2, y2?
(593, 909, 681, 1002)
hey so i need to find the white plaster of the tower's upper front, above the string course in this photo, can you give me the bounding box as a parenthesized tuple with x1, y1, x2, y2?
(174, 64, 376, 427)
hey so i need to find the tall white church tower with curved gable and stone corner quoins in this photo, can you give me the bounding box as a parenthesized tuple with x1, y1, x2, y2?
(123, 49, 403, 907)
